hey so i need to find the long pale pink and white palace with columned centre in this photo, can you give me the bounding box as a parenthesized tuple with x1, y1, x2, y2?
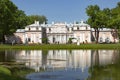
(14, 21, 119, 44)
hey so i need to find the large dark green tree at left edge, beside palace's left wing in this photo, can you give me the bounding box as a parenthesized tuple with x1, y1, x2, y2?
(0, 0, 25, 42)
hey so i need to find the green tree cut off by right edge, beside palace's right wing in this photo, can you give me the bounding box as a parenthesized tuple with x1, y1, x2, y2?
(108, 2, 120, 43)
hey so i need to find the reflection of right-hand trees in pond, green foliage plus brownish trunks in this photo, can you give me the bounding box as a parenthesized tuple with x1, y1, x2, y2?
(87, 50, 120, 80)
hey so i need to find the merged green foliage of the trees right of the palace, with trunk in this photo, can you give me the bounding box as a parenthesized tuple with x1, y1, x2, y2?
(86, 2, 120, 43)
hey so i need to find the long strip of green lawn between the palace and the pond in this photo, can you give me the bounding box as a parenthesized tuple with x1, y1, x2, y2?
(0, 44, 120, 50)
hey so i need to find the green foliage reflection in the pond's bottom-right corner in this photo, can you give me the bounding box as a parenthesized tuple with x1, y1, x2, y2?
(87, 63, 120, 80)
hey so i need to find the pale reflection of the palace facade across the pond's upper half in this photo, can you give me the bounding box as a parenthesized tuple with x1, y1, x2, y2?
(0, 50, 119, 72)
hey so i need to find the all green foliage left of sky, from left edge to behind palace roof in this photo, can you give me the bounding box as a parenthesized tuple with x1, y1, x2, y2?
(0, 0, 47, 42)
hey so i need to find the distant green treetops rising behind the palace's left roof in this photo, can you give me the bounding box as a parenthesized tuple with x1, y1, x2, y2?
(27, 15, 47, 24)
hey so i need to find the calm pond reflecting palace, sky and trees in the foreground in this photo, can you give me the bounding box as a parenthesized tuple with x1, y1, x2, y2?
(0, 50, 120, 80)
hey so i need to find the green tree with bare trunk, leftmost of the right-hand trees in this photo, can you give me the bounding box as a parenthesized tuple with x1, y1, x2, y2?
(86, 5, 100, 43)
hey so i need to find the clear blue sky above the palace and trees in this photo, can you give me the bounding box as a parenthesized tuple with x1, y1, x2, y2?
(11, 0, 120, 23)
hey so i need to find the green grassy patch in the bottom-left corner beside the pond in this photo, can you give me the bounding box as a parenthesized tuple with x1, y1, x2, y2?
(0, 66, 32, 80)
